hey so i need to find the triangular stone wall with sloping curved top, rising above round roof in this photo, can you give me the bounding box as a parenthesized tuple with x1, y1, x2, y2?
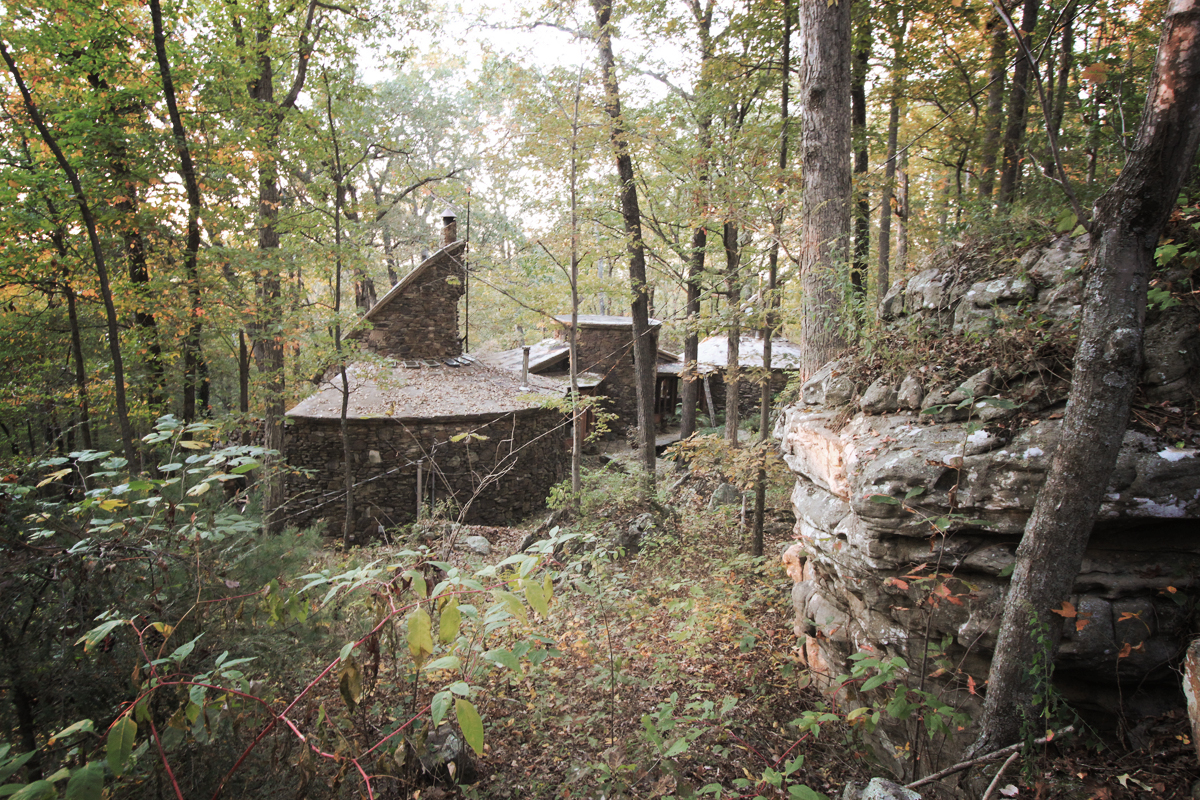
(346, 242, 466, 359)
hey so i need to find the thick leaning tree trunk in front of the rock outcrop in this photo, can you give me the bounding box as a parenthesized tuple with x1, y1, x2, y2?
(973, 0, 1200, 753)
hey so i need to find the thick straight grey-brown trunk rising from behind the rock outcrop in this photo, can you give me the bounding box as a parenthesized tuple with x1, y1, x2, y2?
(797, 0, 851, 375)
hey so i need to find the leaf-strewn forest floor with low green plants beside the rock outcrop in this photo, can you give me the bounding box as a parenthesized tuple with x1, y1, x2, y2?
(348, 455, 1200, 800)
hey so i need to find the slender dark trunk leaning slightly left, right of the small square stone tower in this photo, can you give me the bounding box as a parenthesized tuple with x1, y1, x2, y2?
(592, 0, 658, 494)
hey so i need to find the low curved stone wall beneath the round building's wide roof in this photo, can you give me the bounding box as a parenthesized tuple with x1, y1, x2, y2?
(284, 409, 569, 541)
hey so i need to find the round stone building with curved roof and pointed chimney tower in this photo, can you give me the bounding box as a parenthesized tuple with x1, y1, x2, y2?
(284, 218, 568, 541)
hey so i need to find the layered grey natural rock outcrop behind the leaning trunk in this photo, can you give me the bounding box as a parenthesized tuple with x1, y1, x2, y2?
(775, 231, 1200, 753)
